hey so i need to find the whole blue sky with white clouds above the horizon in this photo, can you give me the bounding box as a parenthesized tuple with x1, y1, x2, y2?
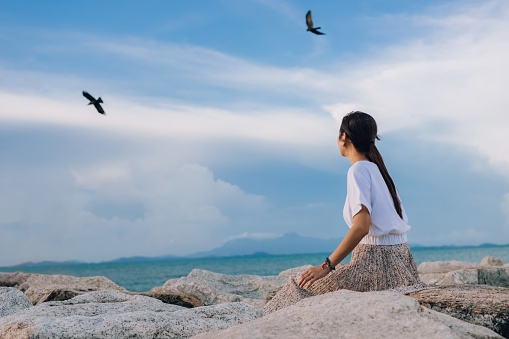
(0, 0, 509, 266)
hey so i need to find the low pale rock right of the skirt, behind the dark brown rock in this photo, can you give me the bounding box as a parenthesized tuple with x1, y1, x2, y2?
(417, 261, 509, 287)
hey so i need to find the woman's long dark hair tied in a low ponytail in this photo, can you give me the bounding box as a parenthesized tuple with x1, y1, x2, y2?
(339, 111, 403, 219)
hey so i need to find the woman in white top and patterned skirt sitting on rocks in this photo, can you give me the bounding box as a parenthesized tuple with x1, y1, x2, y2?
(263, 112, 427, 314)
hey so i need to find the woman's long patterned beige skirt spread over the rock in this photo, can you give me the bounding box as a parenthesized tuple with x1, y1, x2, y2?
(263, 243, 429, 314)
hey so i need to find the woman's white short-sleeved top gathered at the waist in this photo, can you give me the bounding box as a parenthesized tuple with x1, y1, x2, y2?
(343, 160, 411, 245)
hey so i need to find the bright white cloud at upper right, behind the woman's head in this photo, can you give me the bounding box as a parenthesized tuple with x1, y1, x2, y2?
(324, 1, 509, 178)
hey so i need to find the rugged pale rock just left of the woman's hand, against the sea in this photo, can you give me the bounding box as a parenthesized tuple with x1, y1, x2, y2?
(150, 265, 311, 309)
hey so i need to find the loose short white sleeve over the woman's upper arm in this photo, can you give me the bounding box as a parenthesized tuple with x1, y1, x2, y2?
(347, 167, 371, 218)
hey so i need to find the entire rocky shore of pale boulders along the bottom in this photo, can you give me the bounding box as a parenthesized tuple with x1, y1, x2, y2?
(0, 257, 509, 338)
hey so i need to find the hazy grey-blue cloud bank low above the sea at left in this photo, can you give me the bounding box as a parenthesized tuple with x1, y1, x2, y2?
(0, 164, 269, 265)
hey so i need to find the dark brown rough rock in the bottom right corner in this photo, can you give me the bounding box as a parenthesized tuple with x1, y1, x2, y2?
(408, 285, 509, 338)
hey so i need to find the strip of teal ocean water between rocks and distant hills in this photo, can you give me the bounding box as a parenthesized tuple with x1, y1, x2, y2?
(0, 246, 509, 292)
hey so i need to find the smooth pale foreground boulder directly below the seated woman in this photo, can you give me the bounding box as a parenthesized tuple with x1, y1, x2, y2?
(196, 290, 501, 339)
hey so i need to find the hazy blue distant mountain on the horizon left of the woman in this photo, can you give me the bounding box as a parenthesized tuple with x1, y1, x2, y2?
(187, 233, 341, 258)
